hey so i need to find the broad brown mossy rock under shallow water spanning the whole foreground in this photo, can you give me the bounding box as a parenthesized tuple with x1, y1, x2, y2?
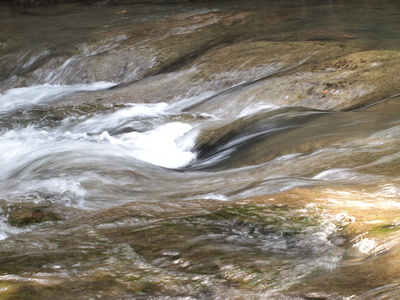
(0, 187, 400, 299)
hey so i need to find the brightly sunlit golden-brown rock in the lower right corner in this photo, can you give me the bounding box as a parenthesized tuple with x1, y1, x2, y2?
(245, 186, 400, 299)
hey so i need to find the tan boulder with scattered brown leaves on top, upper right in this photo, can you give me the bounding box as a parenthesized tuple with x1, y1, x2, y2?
(187, 51, 400, 118)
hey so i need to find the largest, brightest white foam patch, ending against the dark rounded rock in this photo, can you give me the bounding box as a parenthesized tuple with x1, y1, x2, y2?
(0, 109, 197, 180)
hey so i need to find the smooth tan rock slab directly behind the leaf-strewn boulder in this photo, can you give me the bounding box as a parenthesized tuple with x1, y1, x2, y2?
(57, 39, 360, 108)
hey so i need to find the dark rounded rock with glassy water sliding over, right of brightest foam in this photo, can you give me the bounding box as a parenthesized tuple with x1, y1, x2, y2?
(189, 99, 399, 170)
